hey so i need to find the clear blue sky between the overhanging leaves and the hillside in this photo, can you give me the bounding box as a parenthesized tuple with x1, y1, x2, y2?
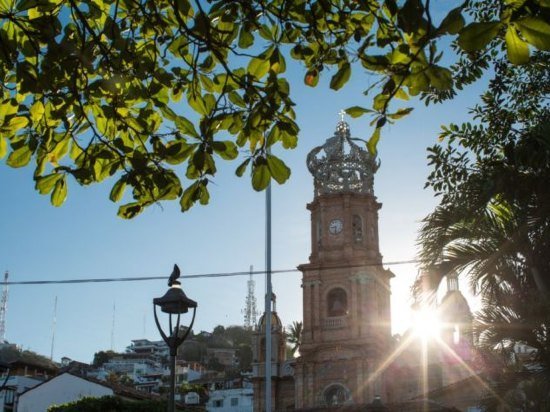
(0, 57, 486, 362)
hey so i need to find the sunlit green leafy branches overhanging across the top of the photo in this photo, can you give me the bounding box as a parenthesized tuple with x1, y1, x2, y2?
(0, 0, 550, 218)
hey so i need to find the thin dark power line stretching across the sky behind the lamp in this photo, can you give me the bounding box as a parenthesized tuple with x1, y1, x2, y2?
(4, 259, 420, 286)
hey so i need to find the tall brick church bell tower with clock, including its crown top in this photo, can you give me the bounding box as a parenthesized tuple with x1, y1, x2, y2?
(295, 120, 393, 409)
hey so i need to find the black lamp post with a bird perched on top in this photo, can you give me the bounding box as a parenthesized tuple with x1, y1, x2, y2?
(153, 265, 197, 412)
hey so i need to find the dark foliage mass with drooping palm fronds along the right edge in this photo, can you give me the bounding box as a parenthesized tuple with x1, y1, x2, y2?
(413, 53, 550, 408)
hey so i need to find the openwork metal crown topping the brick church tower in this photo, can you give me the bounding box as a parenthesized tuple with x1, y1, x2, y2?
(307, 113, 380, 196)
